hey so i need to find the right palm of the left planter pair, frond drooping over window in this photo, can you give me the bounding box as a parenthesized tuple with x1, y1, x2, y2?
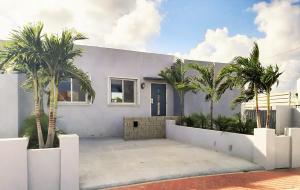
(43, 30, 95, 147)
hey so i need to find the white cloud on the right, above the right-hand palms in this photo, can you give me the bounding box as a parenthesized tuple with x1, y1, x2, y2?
(182, 0, 300, 91)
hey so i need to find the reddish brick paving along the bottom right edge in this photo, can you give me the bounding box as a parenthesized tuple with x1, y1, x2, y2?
(111, 169, 300, 190)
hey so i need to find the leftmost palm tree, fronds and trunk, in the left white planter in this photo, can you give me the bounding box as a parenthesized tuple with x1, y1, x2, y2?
(0, 23, 44, 148)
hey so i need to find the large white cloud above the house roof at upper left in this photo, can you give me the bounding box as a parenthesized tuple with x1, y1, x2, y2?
(0, 0, 162, 49)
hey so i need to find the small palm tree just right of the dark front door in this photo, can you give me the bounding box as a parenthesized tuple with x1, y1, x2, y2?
(159, 59, 191, 124)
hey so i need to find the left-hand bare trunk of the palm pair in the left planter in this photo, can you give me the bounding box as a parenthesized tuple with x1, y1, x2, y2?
(33, 80, 45, 148)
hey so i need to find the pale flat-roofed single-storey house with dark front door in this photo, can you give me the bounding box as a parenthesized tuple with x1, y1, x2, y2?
(0, 46, 240, 137)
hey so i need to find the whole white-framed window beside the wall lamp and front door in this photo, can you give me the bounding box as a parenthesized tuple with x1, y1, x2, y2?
(109, 78, 137, 104)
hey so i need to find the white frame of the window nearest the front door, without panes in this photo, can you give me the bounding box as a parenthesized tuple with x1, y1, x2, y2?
(107, 76, 140, 106)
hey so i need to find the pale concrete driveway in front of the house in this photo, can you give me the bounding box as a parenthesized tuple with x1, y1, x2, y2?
(80, 139, 261, 189)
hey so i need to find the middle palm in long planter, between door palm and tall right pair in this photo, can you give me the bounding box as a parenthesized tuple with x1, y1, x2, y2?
(189, 63, 230, 129)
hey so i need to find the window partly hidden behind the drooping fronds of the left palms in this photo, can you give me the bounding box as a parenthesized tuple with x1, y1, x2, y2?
(58, 78, 89, 103)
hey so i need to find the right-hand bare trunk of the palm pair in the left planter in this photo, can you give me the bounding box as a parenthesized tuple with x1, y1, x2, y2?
(46, 79, 56, 148)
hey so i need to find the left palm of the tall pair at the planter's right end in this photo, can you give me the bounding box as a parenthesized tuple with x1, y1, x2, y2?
(220, 43, 263, 128)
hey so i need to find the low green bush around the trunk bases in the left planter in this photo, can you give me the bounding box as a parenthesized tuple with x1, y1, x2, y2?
(20, 114, 64, 149)
